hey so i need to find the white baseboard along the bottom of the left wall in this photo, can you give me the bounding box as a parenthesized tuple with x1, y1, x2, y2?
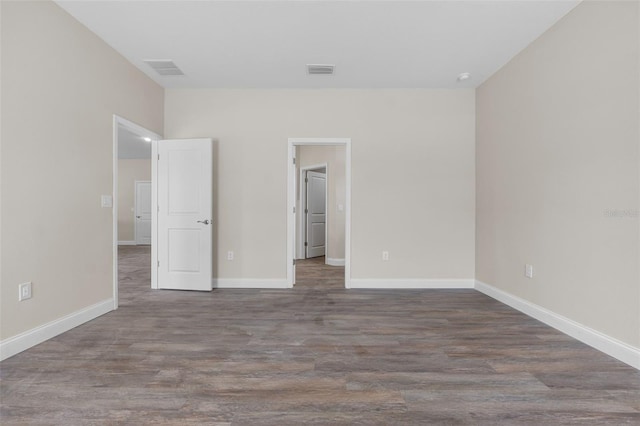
(0, 299, 113, 361)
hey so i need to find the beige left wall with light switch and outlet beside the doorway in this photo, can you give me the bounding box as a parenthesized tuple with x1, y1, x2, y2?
(0, 1, 163, 339)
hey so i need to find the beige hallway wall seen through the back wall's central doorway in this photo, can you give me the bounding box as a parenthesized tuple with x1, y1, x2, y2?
(296, 145, 346, 260)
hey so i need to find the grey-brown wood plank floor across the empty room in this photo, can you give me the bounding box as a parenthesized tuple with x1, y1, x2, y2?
(0, 247, 640, 425)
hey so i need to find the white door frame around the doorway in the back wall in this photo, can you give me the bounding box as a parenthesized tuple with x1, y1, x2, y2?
(286, 138, 351, 288)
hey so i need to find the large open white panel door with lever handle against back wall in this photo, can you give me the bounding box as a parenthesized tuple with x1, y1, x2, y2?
(157, 139, 213, 291)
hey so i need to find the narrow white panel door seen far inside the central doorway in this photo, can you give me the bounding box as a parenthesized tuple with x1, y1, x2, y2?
(305, 171, 327, 258)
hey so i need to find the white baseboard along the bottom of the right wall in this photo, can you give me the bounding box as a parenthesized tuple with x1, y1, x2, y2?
(475, 280, 640, 370)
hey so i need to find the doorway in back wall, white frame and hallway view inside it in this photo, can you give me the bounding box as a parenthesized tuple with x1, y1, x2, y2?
(287, 138, 351, 288)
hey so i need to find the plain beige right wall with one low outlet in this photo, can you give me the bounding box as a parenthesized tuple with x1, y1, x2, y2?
(476, 2, 640, 347)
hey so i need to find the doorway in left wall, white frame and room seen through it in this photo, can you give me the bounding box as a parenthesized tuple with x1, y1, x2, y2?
(112, 115, 161, 309)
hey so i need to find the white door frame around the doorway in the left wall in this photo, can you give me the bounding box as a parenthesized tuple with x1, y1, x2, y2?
(111, 114, 162, 309)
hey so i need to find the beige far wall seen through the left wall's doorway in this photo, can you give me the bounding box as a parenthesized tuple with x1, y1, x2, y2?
(118, 158, 151, 241)
